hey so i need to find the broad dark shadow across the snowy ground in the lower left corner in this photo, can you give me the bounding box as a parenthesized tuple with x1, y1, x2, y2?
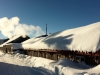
(0, 62, 55, 75)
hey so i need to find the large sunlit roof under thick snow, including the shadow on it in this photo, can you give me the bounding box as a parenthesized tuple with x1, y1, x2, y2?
(22, 22, 100, 52)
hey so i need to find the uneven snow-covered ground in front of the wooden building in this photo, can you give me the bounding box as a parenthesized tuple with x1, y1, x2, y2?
(0, 52, 100, 75)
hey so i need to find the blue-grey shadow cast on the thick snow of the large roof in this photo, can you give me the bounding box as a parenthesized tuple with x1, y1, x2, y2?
(43, 33, 73, 49)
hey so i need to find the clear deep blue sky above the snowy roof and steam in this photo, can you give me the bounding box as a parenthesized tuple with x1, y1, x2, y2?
(0, 0, 100, 38)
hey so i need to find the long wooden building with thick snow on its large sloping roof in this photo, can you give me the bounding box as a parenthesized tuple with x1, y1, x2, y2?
(0, 22, 100, 65)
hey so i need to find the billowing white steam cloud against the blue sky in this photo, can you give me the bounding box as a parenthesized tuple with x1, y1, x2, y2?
(0, 17, 44, 38)
